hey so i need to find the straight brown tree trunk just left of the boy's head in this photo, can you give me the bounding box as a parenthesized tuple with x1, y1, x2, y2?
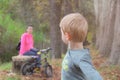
(49, 0, 62, 58)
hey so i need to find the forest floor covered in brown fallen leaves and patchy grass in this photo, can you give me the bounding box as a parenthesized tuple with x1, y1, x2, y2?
(0, 48, 120, 80)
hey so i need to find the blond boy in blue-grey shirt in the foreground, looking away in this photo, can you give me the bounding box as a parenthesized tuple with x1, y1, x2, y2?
(60, 13, 103, 80)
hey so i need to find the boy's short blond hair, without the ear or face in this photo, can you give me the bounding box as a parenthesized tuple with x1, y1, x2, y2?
(60, 13, 88, 42)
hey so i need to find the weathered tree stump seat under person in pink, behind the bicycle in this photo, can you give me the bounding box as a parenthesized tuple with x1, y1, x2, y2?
(12, 56, 32, 74)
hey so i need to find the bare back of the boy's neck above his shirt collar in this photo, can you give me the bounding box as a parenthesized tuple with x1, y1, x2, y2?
(68, 42, 83, 50)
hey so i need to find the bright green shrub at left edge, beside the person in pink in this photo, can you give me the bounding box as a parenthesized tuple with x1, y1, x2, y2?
(0, 14, 25, 62)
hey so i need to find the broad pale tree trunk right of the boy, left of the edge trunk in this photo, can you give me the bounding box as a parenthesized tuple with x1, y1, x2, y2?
(94, 0, 116, 56)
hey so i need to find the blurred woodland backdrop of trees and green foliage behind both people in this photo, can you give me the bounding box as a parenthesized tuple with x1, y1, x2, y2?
(0, 0, 120, 65)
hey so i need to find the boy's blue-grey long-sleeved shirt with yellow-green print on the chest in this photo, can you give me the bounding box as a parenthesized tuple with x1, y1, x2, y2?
(61, 49, 103, 80)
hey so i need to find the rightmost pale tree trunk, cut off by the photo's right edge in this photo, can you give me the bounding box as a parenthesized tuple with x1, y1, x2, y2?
(109, 0, 120, 65)
